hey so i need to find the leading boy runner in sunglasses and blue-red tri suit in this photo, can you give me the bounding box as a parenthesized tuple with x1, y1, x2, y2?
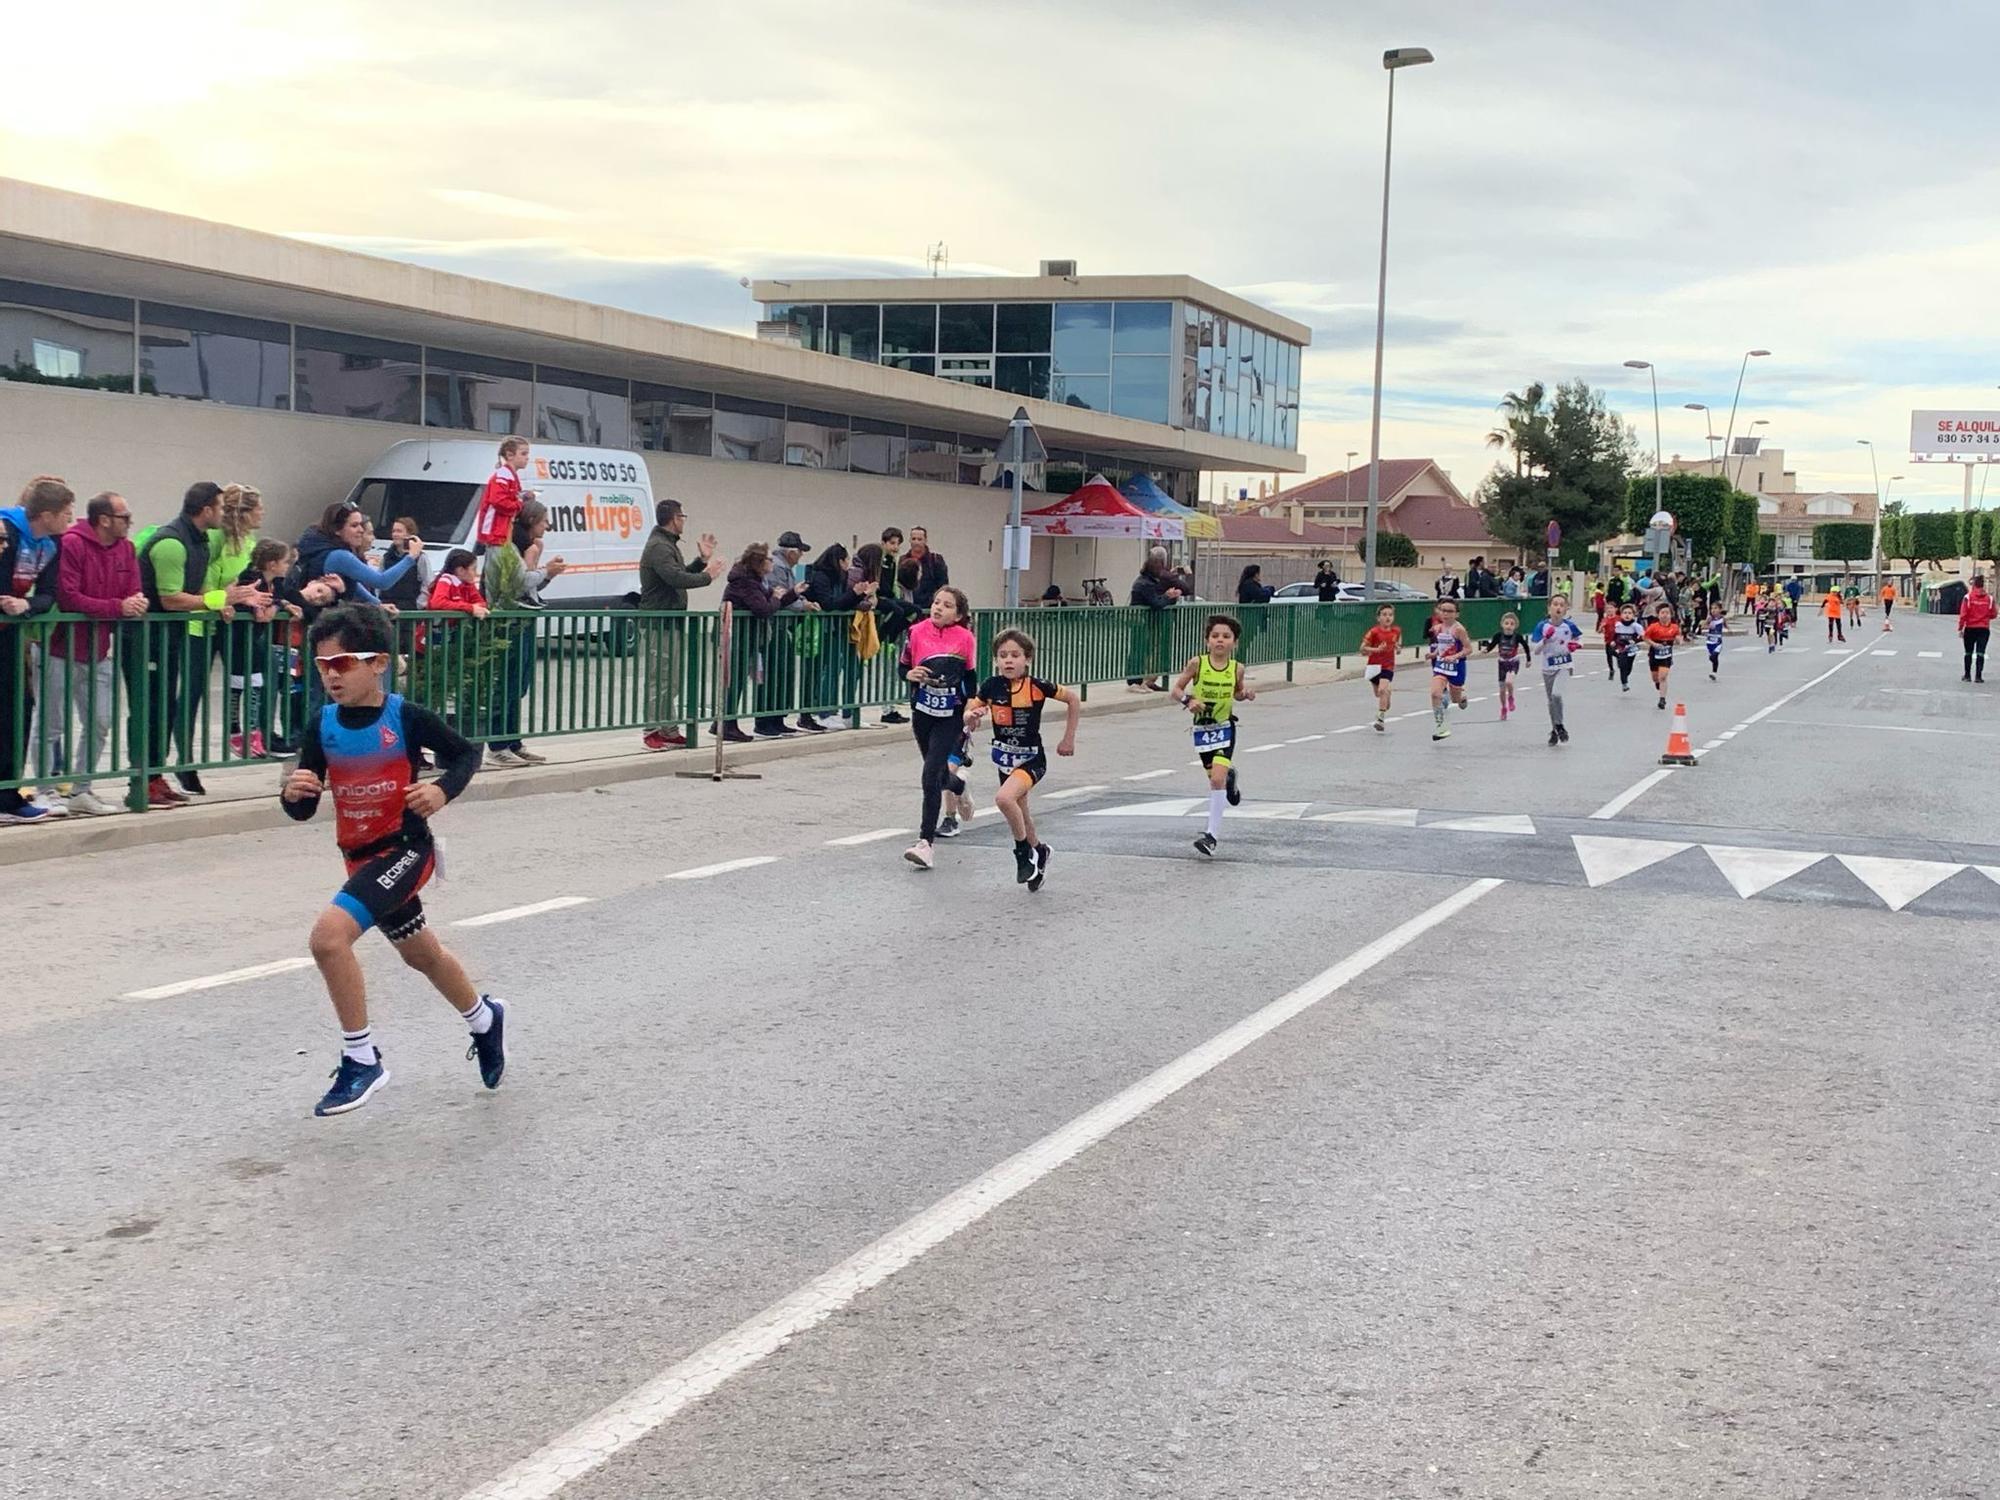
(284, 604, 506, 1114)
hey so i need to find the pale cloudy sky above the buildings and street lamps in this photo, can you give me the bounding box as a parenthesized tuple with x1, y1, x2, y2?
(0, 0, 2000, 506)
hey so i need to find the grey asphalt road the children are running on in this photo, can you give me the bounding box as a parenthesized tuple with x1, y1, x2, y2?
(0, 620, 2000, 1500)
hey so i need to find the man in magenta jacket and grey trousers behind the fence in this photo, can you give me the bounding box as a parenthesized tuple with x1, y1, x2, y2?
(40, 490, 146, 816)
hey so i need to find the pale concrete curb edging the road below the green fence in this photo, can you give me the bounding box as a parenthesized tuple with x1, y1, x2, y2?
(0, 666, 1360, 868)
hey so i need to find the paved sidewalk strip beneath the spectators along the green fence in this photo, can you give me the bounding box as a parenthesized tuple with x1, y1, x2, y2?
(0, 658, 1362, 866)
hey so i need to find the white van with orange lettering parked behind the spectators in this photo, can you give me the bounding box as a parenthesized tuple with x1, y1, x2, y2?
(348, 438, 652, 610)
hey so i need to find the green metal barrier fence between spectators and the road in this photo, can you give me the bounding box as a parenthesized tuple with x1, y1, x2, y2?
(0, 600, 1546, 810)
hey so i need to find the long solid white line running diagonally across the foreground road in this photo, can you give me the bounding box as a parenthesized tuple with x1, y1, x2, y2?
(466, 880, 1502, 1500)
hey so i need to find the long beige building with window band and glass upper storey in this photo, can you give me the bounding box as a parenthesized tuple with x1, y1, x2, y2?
(0, 178, 1308, 604)
